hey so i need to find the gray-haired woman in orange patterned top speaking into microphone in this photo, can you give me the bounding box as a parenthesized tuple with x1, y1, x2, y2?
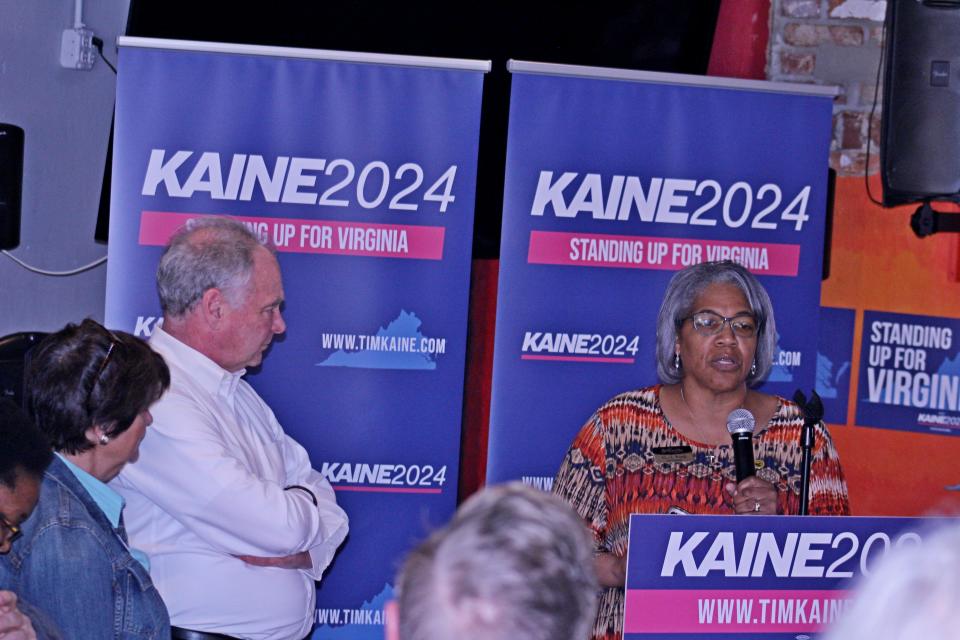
(553, 262, 850, 639)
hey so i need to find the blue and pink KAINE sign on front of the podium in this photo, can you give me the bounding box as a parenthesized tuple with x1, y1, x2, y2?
(624, 515, 943, 640)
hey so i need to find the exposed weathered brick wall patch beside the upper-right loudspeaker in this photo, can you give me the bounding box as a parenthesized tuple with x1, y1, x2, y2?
(767, 0, 887, 176)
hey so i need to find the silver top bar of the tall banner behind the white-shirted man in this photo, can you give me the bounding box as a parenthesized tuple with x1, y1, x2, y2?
(117, 36, 492, 73)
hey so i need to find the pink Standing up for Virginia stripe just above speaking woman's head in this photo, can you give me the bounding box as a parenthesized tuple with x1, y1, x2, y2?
(527, 231, 800, 276)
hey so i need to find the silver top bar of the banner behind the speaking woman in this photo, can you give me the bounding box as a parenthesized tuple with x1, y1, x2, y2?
(507, 60, 840, 98)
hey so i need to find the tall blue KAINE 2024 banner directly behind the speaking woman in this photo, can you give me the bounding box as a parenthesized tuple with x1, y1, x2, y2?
(487, 63, 831, 488)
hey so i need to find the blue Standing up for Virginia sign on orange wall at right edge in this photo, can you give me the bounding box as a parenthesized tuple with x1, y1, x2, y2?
(857, 310, 960, 435)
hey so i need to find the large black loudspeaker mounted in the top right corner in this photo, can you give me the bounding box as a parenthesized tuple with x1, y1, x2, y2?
(880, 0, 960, 206)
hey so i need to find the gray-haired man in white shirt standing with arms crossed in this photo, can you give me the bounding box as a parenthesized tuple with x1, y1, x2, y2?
(114, 218, 347, 640)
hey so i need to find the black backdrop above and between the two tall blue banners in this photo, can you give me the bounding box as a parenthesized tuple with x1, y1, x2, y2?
(127, 0, 720, 258)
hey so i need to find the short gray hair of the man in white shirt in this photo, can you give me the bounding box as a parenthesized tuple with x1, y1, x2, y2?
(157, 217, 272, 318)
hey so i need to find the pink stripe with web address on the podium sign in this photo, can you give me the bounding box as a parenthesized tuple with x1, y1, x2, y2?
(624, 589, 848, 634)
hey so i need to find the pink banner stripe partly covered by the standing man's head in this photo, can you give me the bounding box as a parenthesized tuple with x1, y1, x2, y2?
(139, 211, 446, 260)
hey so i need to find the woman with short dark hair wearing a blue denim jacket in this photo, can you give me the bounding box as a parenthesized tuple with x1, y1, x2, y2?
(0, 320, 170, 640)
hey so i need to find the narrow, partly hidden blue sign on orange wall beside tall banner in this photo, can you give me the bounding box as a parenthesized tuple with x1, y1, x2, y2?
(815, 307, 857, 424)
